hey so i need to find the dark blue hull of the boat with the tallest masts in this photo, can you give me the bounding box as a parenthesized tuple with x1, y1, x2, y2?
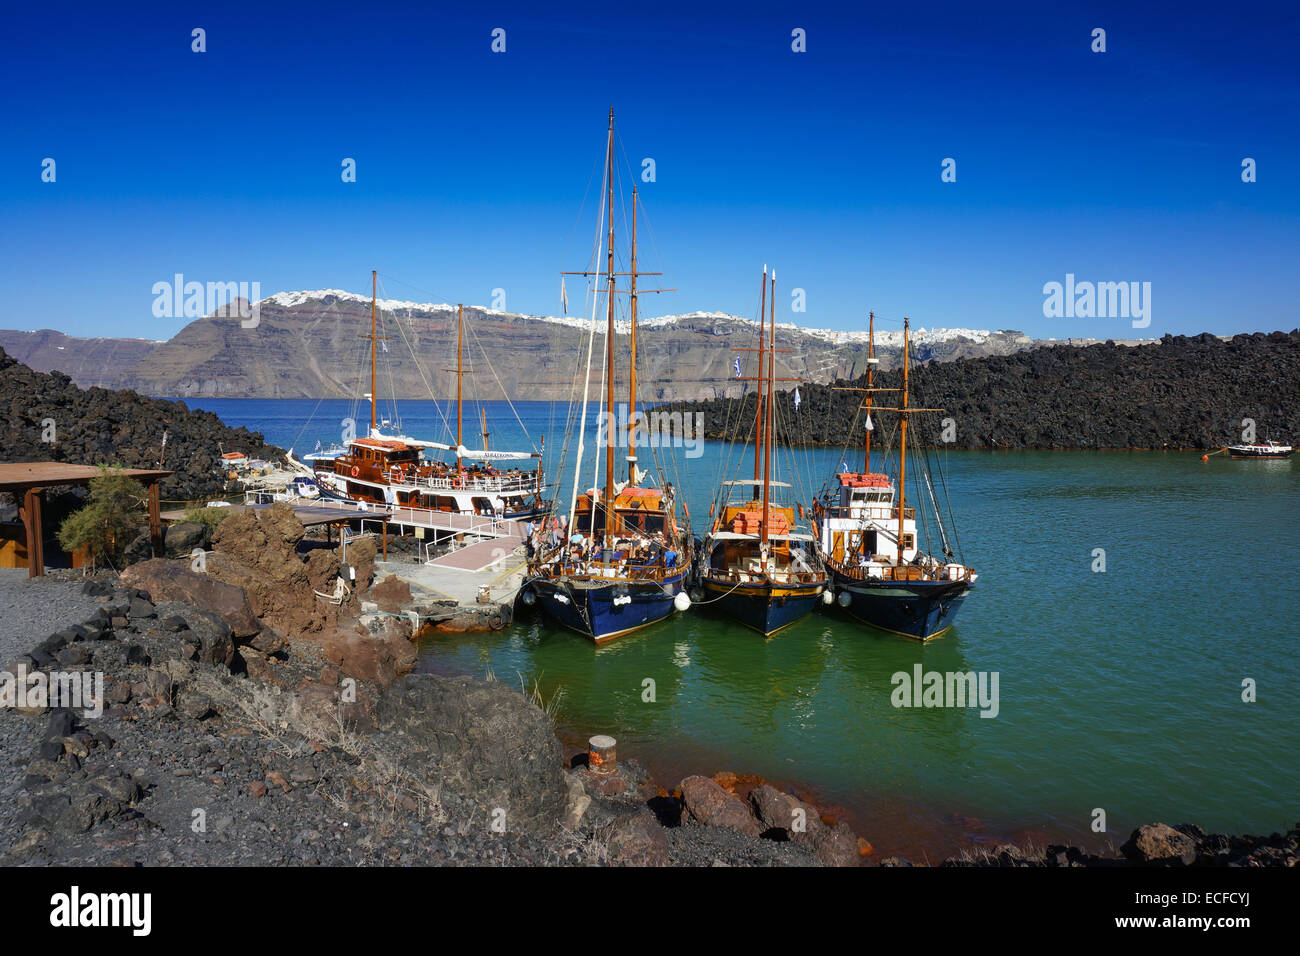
(527, 570, 686, 644)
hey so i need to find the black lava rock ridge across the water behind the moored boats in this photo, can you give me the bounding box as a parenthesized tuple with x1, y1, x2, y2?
(657, 329, 1300, 451)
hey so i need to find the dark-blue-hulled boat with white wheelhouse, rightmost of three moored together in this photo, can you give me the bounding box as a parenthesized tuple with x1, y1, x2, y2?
(814, 313, 979, 640)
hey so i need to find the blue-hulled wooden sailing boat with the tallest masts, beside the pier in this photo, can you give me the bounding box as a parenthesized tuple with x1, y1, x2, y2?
(523, 109, 692, 644)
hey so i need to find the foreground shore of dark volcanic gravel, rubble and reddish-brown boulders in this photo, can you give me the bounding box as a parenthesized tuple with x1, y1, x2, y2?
(0, 506, 1300, 866)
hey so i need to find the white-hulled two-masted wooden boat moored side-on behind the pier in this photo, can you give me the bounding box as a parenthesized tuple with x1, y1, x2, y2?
(303, 272, 546, 519)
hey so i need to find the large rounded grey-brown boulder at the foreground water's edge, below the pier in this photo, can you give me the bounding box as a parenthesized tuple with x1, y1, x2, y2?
(372, 674, 568, 835)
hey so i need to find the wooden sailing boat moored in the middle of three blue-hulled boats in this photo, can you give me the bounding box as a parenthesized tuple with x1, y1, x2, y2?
(697, 267, 827, 636)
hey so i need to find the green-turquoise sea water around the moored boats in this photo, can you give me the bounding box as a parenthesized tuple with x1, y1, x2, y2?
(180, 399, 1300, 858)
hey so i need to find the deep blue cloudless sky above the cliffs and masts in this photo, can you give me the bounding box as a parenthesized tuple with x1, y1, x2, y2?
(0, 0, 1300, 338)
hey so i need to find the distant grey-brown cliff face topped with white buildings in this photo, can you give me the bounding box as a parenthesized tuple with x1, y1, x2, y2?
(0, 290, 1044, 402)
